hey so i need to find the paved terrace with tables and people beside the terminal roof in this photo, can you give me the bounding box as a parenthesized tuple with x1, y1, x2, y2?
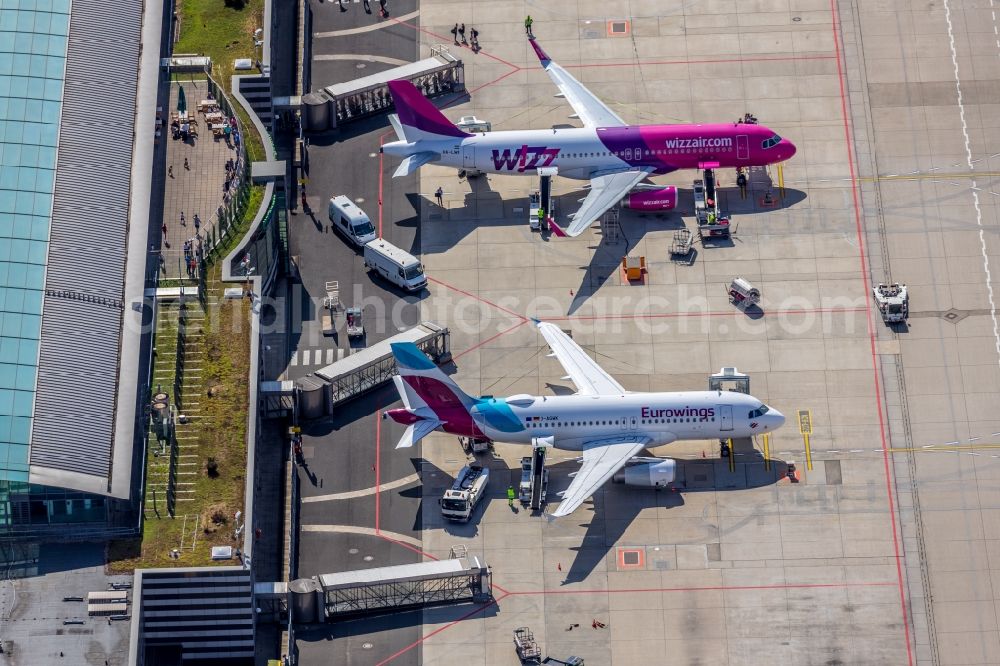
(160, 80, 245, 279)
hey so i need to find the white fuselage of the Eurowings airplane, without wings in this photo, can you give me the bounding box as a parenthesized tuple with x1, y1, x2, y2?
(414, 391, 784, 451)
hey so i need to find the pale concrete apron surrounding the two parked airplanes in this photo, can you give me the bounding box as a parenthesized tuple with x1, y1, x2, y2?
(292, 0, 1000, 665)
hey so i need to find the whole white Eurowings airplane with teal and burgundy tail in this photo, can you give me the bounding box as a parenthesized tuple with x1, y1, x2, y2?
(386, 321, 785, 517)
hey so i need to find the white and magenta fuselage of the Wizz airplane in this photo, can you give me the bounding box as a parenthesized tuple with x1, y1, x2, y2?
(383, 123, 795, 180)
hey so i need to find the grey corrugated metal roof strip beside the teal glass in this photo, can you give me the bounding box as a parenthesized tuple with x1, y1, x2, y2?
(30, 0, 142, 477)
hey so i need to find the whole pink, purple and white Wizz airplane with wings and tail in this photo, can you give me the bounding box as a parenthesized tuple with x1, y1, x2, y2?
(382, 39, 795, 236)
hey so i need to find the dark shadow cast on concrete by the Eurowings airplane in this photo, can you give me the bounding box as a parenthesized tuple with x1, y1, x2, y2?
(549, 444, 788, 585)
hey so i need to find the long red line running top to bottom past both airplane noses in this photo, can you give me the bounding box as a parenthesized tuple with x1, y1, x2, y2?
(830, 0, 916, 666)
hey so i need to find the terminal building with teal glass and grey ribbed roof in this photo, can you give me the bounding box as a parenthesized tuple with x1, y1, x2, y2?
(0, 0, 162, 542)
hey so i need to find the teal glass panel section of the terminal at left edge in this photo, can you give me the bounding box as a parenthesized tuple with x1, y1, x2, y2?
(0, 0, 70, 478)
